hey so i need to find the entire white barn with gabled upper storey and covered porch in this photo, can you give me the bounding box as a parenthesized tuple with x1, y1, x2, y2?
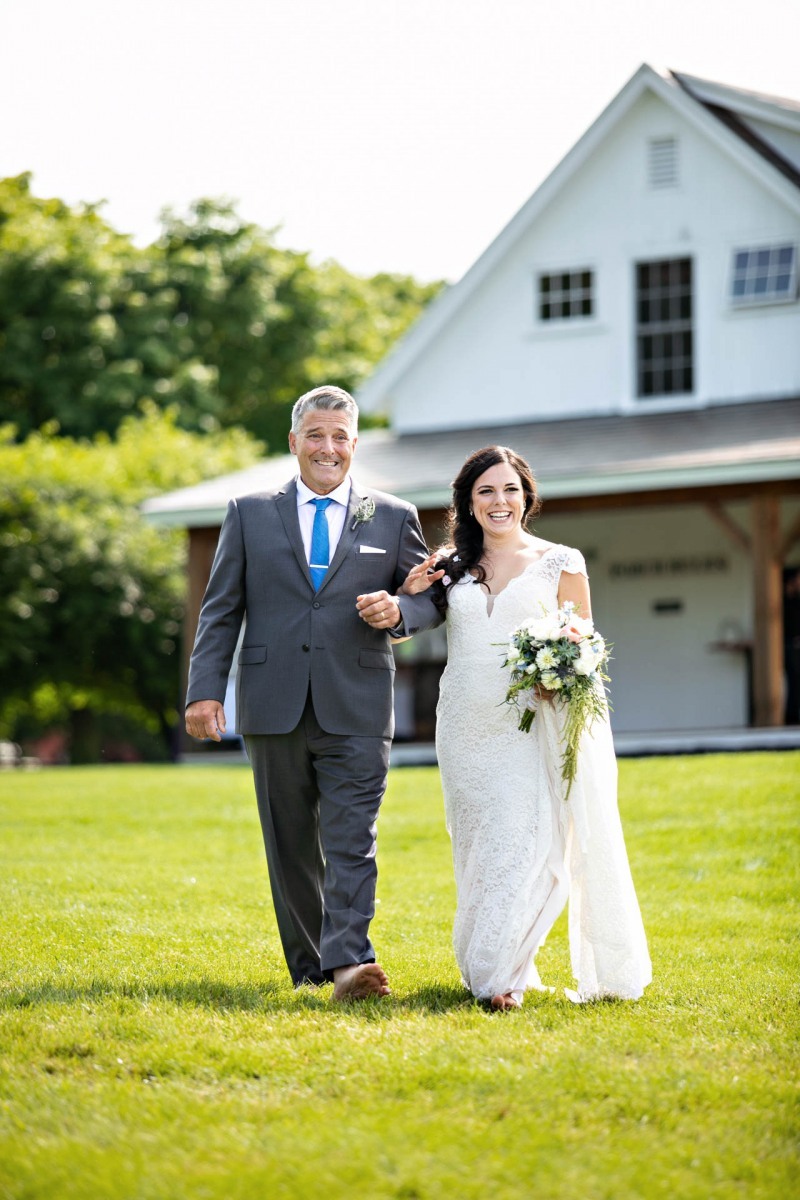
(146, 65, 800, 738)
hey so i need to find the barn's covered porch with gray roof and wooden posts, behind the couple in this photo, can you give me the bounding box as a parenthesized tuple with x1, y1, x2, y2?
(145, 397, 800, 746)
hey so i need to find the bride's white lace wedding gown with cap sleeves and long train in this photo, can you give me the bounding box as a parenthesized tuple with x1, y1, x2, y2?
(437, 546, 651, 1001)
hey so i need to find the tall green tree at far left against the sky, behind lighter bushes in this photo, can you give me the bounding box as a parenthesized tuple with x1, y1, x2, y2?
(0, 174, 223, 437)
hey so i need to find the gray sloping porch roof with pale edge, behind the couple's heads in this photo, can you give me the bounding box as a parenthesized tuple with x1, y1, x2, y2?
(143, 397, 800, 528)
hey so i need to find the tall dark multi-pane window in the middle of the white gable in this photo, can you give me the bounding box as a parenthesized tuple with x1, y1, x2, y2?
(636, 258, 694, 400)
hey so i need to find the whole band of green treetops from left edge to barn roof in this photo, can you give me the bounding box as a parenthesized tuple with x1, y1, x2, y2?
(0, 174, 440, 450)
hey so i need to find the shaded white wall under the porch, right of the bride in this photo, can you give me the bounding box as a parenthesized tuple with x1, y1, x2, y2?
(536, 502, 800, 733)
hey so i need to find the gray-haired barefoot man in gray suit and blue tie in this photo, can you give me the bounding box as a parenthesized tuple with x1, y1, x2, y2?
(186, 388, 437, 1000)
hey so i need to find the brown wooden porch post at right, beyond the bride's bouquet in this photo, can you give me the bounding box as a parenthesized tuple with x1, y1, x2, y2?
(752, 496, 783, 726)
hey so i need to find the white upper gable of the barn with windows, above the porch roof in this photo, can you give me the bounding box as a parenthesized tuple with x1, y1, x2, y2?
(360, 66, 800, 434)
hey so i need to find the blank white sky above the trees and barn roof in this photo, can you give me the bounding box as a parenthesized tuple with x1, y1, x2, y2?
(0, 0, 800, 280)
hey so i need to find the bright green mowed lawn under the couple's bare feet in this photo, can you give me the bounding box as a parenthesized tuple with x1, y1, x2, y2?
(0, 754, 800, 1200)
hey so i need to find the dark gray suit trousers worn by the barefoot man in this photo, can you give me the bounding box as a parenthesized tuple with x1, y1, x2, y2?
(245, 694, 391, 985)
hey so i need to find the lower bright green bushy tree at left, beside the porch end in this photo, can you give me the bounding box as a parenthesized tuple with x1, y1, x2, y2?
(0, 407, 261, 761)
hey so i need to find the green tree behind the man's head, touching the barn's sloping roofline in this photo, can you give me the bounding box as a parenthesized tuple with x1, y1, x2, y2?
(154, 199, 441, 451)
